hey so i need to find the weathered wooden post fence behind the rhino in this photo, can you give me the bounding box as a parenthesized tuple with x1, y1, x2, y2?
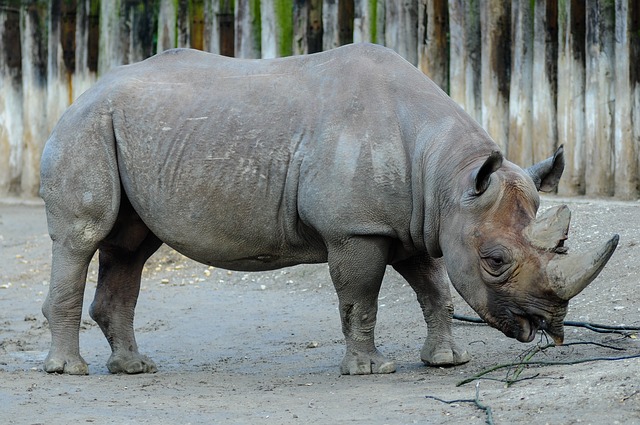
(0, 0, 640, 199)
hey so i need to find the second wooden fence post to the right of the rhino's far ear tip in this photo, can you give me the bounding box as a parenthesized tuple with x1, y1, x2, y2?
(585, 0, 615, 196)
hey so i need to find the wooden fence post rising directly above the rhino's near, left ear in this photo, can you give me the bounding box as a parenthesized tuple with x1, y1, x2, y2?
(480, 0, 511, 154)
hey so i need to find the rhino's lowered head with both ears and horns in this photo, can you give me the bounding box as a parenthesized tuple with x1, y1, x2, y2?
(438, 147, 618, 344)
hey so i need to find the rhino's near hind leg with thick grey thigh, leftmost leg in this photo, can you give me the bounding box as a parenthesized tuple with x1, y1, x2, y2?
(40, 124, 120, 375)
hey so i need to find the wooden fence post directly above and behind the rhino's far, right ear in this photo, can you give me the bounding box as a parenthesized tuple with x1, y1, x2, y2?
(532, 0, 558, 163)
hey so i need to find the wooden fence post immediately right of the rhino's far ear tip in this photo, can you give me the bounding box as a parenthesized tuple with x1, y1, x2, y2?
(556, 0, 586, 196)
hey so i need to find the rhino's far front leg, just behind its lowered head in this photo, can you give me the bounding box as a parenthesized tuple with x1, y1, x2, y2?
(394, 255, 471, 366)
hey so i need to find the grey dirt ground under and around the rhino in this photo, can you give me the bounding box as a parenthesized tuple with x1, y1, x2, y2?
(0, 197, 640, 424)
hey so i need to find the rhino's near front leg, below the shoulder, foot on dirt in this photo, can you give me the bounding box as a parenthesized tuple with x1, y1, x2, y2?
(328, 237, 396, 375)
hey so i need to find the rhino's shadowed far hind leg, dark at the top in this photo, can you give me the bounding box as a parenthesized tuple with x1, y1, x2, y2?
(89, 196, 162, 374)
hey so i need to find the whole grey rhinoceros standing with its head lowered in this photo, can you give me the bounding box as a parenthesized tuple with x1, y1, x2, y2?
(40, 44, 618, 374)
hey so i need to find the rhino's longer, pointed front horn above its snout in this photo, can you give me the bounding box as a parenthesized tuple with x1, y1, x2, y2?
(547, 235, 620, 301)
